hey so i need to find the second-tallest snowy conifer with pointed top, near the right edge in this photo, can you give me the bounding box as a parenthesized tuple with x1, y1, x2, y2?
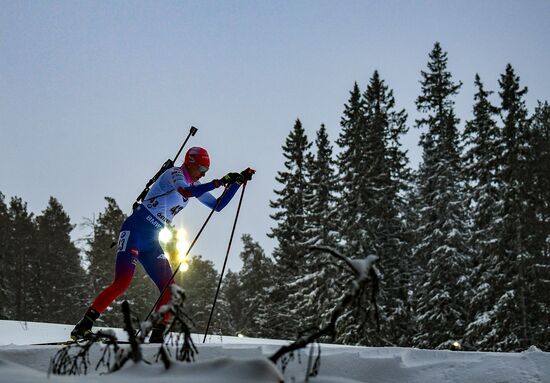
(487, 64, 537, 351)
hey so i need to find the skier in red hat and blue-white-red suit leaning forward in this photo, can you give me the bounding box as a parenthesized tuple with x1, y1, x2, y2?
(71, 147, 253, 343)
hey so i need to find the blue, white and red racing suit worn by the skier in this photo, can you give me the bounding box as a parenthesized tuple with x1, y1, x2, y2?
(91, 166, 239, 313)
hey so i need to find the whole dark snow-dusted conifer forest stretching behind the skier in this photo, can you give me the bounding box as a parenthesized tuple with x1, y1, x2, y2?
(0, 43, 550, 351)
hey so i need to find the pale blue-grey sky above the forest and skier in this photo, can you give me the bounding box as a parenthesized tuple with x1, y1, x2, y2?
(0, 0, 550, 271)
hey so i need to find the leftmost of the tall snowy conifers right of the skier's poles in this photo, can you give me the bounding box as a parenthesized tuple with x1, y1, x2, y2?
(269, 120, 311, 338)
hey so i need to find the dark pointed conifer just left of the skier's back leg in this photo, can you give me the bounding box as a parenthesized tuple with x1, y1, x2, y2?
(33, 197, 88, 323)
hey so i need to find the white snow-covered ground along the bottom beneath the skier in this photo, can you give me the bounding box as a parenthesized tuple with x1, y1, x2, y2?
(0, 321, 550, 383)
